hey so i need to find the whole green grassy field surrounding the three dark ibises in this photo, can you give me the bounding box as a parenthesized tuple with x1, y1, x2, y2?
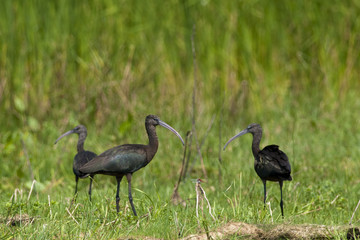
(0, 0, 360, 239)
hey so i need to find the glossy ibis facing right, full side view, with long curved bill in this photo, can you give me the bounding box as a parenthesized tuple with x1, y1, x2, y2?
(80, 115, 184, 216)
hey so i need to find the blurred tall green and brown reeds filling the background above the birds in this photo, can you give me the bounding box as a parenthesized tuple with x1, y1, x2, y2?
(0, 0, 360, 130)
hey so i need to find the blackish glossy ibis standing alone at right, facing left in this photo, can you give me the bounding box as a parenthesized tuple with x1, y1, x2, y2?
(224, 123, 292, 216)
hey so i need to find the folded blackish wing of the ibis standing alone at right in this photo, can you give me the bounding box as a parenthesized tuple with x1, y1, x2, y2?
(259, 145, 291, 174)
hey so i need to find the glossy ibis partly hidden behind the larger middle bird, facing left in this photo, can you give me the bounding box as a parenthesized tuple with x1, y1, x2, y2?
(55, 125, 96, 201)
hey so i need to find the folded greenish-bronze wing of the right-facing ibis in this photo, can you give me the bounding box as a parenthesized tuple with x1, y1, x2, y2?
(80, 144, 148, 174)
